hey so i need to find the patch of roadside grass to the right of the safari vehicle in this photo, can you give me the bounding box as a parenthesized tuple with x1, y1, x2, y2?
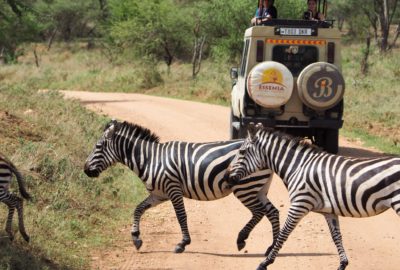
(342, 45, 400, 154)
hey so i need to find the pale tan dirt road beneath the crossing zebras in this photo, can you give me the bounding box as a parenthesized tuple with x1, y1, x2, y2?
(65, 92, 400, 270)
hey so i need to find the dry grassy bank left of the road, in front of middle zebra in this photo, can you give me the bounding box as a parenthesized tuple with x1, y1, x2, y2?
(0, 83, 145, 270)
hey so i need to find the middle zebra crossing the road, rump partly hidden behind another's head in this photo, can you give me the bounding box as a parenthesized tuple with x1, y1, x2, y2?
(84, 120, 279, 253)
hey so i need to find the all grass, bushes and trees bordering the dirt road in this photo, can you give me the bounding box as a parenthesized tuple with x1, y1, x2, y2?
(0, 0, 400, 270)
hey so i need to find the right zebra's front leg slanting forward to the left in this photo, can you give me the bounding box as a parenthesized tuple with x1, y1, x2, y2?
(257, 204, 310, 270)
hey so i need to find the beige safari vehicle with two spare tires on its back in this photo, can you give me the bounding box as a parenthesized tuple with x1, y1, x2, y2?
(230, 0, 345, 153)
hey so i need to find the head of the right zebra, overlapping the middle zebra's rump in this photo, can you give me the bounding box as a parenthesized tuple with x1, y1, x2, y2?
(228, 123, 267, 184)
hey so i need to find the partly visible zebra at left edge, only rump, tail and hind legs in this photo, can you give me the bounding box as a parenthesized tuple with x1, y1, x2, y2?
(0, 153, 31, 242)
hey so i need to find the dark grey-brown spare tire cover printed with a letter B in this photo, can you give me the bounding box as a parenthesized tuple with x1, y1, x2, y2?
(297, 62, 345, 110)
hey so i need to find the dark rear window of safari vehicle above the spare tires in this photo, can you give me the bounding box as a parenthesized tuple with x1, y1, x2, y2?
(272, 45, 318, 77)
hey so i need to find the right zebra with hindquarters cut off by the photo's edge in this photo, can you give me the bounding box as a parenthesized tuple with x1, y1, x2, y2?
(228, 125, 400, 270)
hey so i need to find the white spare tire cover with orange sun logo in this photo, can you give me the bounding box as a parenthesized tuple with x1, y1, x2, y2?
(247, 61, 293, 108)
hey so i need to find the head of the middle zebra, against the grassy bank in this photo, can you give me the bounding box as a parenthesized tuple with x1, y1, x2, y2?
(84, 120, 121, 177)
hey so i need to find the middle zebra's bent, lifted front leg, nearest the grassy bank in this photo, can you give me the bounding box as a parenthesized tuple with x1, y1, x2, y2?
(131, 194, 167, 250)
